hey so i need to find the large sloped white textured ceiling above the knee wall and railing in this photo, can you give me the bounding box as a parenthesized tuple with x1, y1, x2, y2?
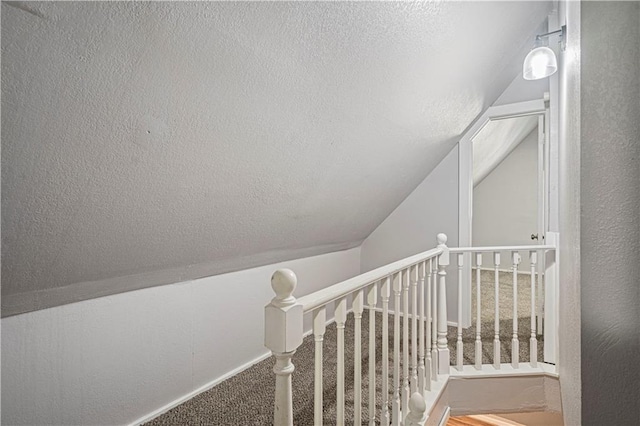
(2, 1, 550, 315)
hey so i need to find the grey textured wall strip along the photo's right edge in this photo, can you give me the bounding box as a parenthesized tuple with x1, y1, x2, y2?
(580, 1, 640, 426)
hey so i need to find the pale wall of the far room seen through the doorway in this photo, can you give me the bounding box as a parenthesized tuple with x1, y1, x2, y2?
(471, 126, 538, 271)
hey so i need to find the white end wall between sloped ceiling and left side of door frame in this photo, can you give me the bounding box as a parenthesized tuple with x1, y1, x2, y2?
(360, 146, 458, 319)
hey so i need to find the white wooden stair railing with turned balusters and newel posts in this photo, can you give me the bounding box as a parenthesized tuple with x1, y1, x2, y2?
(265, 234, 555, 426)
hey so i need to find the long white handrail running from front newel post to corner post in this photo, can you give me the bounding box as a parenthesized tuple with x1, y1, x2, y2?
(297, 248, 442, 313)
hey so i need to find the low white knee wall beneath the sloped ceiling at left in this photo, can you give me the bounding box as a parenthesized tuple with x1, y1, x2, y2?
(1, 248, 360, 425)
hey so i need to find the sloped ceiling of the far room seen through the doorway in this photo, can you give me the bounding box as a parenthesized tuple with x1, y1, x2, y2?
(473, 115, 538, 186)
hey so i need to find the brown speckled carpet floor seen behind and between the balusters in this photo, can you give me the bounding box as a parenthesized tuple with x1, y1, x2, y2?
(147, 271, 543, 426)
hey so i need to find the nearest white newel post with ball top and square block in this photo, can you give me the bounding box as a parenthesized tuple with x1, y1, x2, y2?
(264, 269, 303, 426)
